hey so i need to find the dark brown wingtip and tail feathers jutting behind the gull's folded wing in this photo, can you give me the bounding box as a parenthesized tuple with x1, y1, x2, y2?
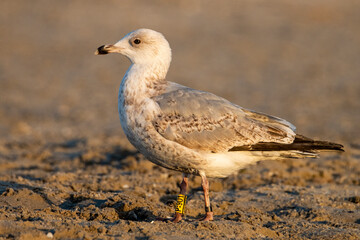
(229, 134, 344, 153)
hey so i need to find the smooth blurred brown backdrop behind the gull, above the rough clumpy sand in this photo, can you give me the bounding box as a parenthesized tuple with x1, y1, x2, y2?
(0, 0, 360, 144)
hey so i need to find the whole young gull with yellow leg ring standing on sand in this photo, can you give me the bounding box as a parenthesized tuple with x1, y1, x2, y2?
(95, 29, 343, 222)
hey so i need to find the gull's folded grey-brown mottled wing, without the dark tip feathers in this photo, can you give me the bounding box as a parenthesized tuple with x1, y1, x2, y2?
(153, 84, 295, 152)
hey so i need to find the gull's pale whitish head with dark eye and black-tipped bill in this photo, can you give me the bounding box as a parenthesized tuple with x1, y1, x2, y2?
(95, 28, 171, 65)
